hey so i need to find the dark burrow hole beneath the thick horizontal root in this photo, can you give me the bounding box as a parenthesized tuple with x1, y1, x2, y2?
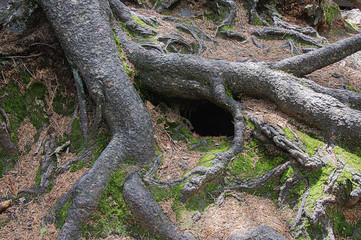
(180, 102, 234, 137)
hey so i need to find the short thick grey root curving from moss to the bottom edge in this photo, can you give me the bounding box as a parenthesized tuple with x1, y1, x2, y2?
(123, 173, 193, 240)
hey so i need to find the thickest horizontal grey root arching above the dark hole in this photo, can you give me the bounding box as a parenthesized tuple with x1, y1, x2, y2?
(116, 25, 361, 145)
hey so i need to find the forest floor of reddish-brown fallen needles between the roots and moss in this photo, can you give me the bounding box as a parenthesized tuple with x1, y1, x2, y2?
(0, 1, 361, 239)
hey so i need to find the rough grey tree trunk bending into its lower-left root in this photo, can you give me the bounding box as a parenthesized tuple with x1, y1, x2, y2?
(41, 0, 154, 239)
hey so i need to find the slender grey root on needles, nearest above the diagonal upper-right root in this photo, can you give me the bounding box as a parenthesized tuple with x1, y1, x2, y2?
(251, 27, 323, 48)
